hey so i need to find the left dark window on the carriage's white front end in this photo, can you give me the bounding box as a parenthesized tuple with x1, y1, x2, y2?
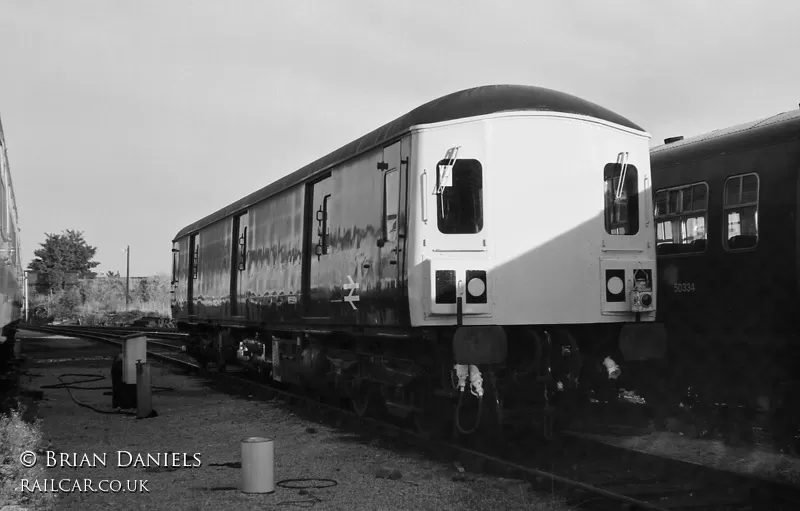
(436, 160, 483, 234)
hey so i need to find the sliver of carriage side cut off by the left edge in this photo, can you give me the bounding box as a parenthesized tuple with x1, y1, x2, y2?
(0, 115, 23, 366)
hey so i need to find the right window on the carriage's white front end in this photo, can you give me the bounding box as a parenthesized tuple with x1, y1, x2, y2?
(603, 163, 639, 236)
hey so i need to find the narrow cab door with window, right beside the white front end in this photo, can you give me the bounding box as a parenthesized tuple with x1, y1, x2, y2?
(378, 142, 407, 312)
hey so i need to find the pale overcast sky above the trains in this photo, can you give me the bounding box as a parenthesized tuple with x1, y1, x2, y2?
(0, 0, 800, 276)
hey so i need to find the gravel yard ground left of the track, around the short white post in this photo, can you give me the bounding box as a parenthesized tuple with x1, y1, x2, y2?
(17, 336, 569, 511)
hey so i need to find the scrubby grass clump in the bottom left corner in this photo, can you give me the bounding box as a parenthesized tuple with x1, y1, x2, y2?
(0, 406, 55, 509)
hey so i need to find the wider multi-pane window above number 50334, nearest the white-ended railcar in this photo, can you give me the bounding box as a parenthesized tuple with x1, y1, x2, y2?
(655, 183, 708, 255)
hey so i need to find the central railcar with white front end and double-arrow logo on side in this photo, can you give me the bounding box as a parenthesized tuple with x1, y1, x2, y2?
(172, 86, 666, 432)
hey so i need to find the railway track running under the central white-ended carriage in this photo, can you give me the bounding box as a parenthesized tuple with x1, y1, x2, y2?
(18, 326, 800, 511)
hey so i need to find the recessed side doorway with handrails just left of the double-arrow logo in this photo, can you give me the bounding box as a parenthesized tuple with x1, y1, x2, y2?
(303, 174, 336, 318)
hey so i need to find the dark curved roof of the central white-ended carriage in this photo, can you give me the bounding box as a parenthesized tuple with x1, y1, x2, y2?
(175, 85, 643, 239)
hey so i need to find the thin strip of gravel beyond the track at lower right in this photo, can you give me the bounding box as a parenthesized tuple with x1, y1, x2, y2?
(575, 432, 800, 485)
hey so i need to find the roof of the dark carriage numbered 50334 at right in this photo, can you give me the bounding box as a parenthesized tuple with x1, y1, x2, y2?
(650, 110, 800, 168)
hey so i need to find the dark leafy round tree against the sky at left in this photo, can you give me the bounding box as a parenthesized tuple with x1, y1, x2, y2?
(28, 229, 100, 289)
